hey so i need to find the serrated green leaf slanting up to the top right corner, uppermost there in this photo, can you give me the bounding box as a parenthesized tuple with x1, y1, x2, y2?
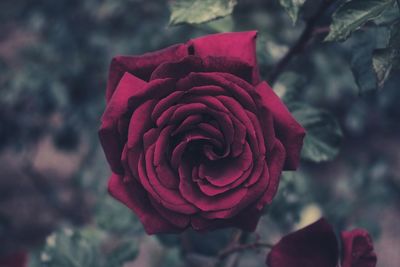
(325, 0, 394, 41)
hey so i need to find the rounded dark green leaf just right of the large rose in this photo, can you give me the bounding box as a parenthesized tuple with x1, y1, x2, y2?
(289, 102, 342, 162)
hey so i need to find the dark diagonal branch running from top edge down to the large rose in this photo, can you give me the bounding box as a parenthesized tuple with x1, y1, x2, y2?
(267, 0, 335, 84)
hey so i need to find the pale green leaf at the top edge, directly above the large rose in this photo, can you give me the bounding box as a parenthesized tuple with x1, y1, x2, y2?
(169, 0, 237, 25)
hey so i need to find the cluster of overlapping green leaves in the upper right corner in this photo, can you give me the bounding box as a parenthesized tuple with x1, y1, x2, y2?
(325, 0, 400, 92)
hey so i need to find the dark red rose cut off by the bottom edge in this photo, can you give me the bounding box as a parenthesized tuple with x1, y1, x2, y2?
(267, 219, 377, 267)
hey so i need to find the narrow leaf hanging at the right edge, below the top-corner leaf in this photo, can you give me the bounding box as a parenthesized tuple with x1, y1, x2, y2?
(372, 22, 400, 88)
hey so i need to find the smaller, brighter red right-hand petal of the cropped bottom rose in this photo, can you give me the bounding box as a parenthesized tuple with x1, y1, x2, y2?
(341, 229, 377, 267)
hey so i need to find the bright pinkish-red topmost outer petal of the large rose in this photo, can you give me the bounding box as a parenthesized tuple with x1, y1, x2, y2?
(188, 31, 260, 85)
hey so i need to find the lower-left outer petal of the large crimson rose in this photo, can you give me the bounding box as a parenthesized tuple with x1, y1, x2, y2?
(108, 174, 179, 235)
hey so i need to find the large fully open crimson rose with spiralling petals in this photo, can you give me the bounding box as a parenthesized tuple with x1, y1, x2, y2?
(99, 31, 304, 234)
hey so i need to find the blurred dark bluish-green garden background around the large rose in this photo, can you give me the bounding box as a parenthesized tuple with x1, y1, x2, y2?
(0, 0, 400, 267)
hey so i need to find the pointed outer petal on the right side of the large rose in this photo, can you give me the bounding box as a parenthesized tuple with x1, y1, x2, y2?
(256, 82, 305, 170)
